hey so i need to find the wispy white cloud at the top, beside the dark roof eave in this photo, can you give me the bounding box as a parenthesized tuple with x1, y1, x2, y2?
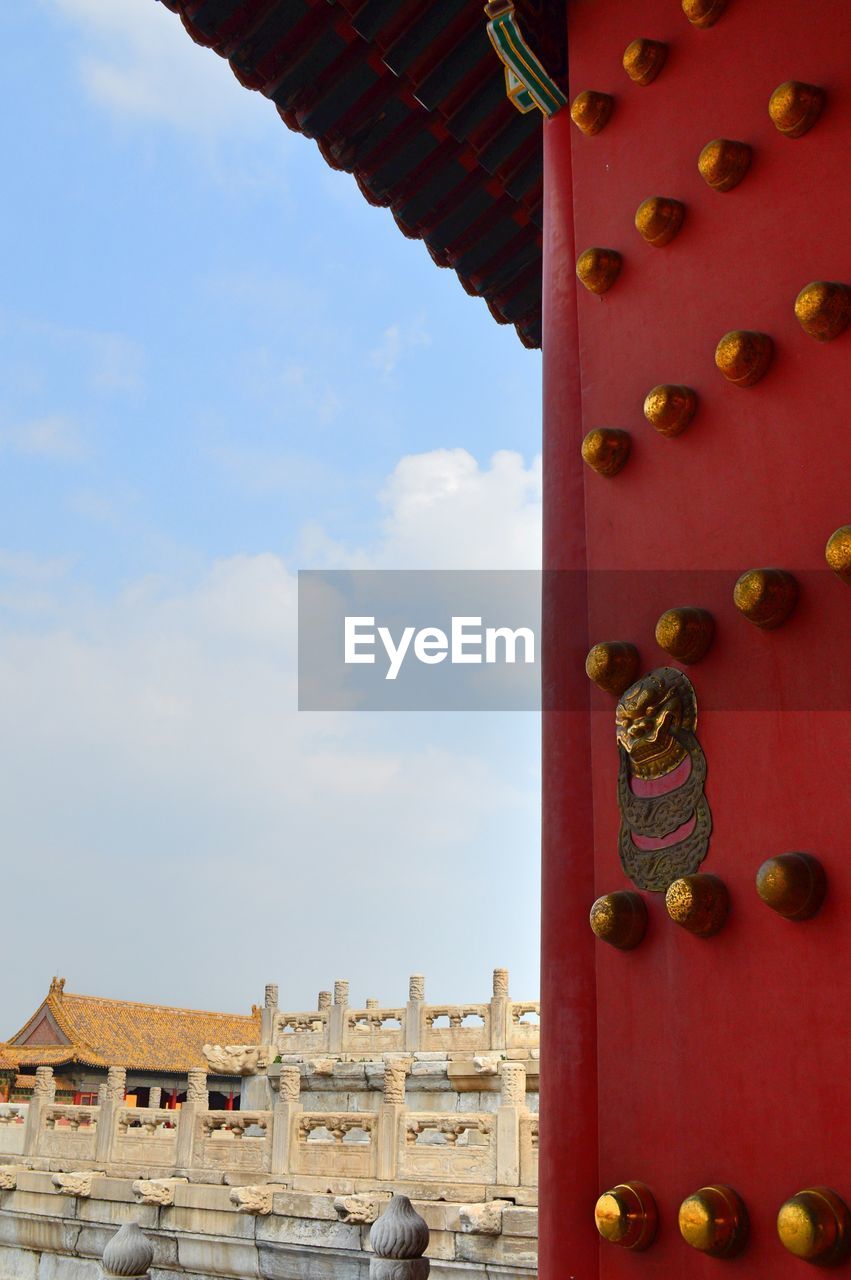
(45, 0, 274, 134)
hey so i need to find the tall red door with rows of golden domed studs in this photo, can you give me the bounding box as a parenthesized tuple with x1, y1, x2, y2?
(541, 0, 851, 1280)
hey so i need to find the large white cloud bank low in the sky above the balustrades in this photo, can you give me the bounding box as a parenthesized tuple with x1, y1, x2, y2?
(0, 451, 537, 1025)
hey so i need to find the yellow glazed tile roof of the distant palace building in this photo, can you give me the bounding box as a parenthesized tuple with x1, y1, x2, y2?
(0, 980, 260, 1073)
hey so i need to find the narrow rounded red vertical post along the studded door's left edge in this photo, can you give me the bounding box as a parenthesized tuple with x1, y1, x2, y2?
(539, 102, 599, 1280)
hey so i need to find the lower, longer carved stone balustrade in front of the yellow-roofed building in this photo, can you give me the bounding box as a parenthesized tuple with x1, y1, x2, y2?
(0, 1060, 537, 1187)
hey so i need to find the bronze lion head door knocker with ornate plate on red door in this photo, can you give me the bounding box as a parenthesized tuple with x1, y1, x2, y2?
(616, 667, 712, 893)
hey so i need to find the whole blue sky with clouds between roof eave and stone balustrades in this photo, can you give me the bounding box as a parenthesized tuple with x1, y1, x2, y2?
(0, 0, 540, 1036)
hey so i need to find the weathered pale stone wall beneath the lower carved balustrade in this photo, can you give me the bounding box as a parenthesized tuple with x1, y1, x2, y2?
(0, 1166, 537, 1280)
